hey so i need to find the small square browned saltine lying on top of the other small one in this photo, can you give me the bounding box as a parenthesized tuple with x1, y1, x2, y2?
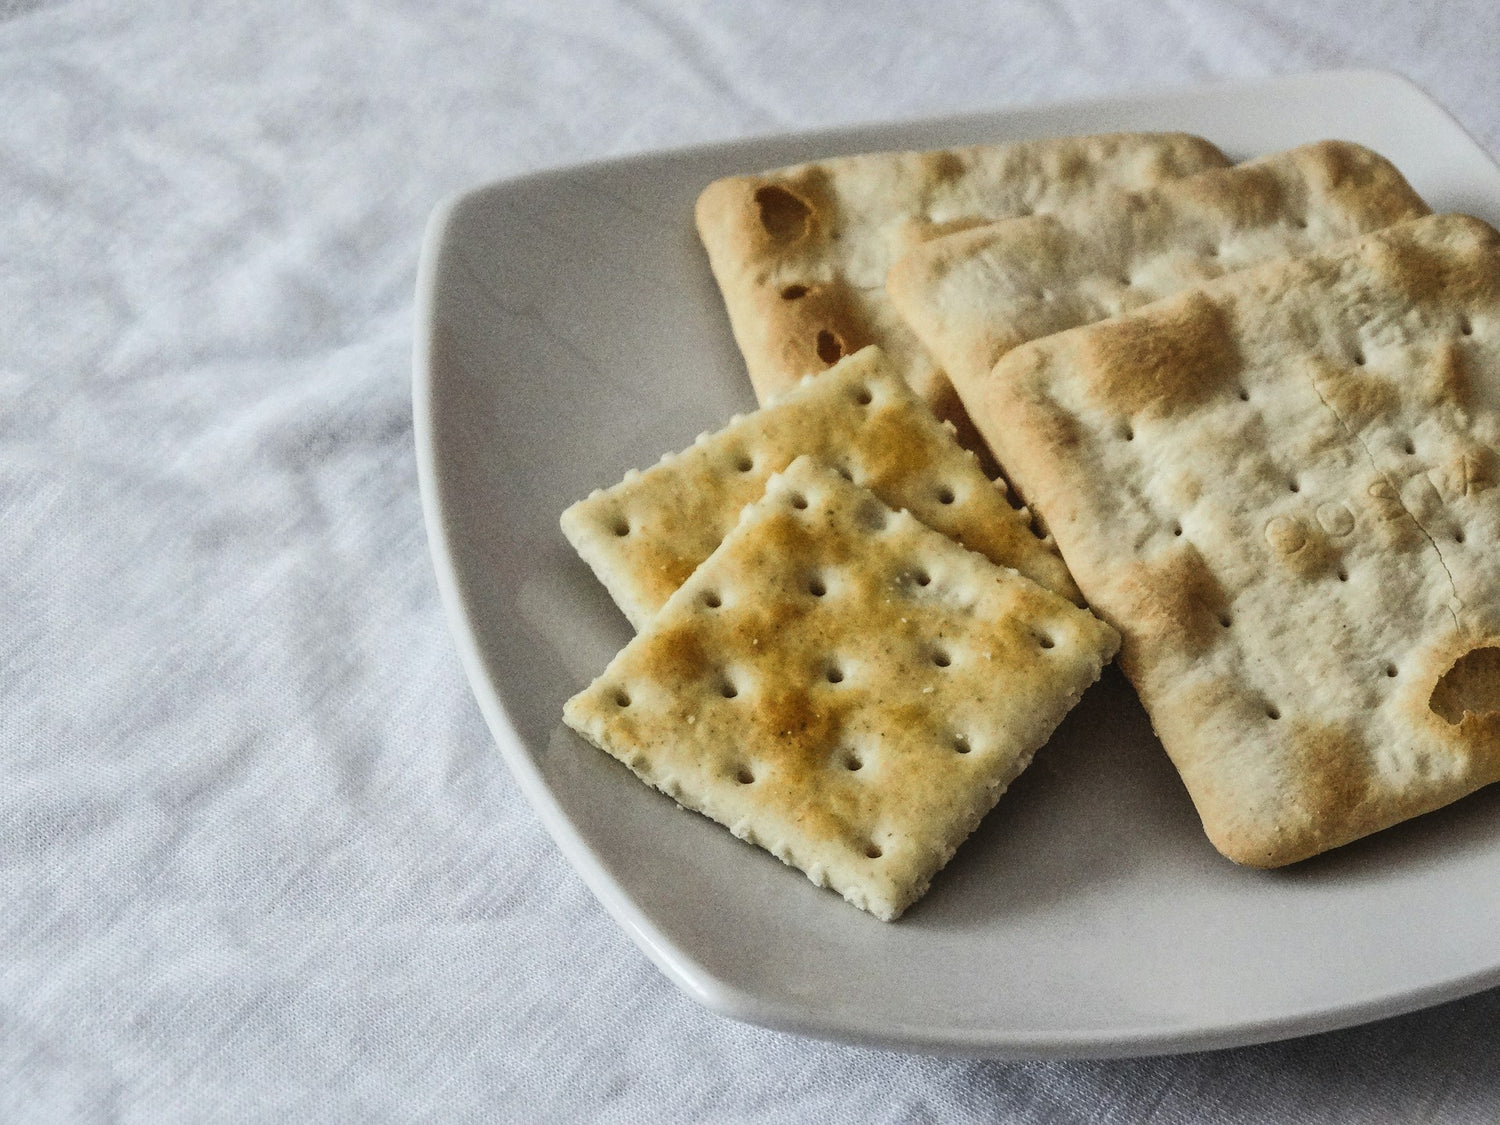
(564, 458, 1118, 921)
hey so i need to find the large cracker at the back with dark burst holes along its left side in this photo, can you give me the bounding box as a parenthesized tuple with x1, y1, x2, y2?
(696, 134, 1229, 450)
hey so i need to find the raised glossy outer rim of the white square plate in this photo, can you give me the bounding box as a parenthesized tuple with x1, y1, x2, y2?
(411, 68, 1500, 1061)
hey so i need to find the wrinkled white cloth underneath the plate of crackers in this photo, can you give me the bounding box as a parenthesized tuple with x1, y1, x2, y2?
(0, 0, 1500, 1122)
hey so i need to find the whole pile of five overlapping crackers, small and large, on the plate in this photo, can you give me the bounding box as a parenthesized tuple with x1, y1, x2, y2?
(563, 134, 1500, 920)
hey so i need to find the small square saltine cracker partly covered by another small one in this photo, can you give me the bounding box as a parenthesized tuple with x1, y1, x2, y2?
(561, 348, 1079, 629)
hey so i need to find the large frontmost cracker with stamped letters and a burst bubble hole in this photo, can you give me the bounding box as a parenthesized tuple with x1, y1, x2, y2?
(977, 215, 1500, 867)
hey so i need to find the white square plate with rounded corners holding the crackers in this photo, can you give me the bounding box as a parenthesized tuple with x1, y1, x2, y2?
(416, 72, 1500, 1058)
